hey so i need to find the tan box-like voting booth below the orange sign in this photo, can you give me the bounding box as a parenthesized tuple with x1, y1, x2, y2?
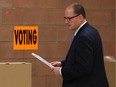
(0, 62, 31, 87)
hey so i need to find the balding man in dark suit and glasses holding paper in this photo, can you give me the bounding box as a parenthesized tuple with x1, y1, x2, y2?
(51, 3, 109, 87)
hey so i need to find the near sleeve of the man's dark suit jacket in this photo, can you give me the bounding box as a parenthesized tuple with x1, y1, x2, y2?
(61, 36, 93, 80)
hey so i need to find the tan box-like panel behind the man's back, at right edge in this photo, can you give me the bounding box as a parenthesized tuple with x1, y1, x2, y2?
(105, 62, 116, 87)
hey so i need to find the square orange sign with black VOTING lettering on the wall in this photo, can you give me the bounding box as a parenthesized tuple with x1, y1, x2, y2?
(14, 26, 38, 50)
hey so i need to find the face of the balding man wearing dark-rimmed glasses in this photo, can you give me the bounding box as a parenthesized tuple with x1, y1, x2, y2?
(64, 8, 80, 30)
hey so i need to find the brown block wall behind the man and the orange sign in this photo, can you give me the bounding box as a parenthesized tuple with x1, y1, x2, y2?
(0, 0, 116, 87)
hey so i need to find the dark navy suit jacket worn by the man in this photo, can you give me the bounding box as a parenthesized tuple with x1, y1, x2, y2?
(61, 23, 109, 87)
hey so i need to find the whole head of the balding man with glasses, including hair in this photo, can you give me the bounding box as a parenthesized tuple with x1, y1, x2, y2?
(64, 3, 86, 30)
